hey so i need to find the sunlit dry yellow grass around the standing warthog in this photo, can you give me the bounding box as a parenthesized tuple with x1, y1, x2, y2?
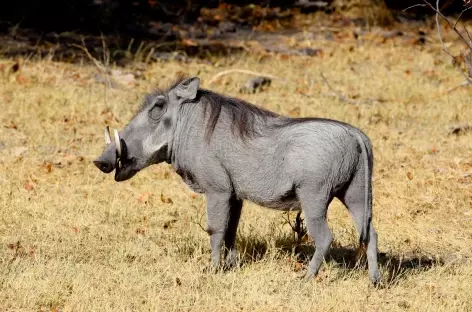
(0, 28, 472, 311)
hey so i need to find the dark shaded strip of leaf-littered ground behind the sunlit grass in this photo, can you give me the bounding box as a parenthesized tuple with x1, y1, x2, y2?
(0, 0, 472, 65)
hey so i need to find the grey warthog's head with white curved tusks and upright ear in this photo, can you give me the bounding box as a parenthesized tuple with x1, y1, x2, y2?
(93, 77, 200, 182)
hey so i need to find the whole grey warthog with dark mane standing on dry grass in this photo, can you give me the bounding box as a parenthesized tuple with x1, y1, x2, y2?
(94, 77, 381, 283)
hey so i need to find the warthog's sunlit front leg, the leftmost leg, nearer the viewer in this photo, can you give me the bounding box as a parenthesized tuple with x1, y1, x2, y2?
(206, 193, 233, 270)
